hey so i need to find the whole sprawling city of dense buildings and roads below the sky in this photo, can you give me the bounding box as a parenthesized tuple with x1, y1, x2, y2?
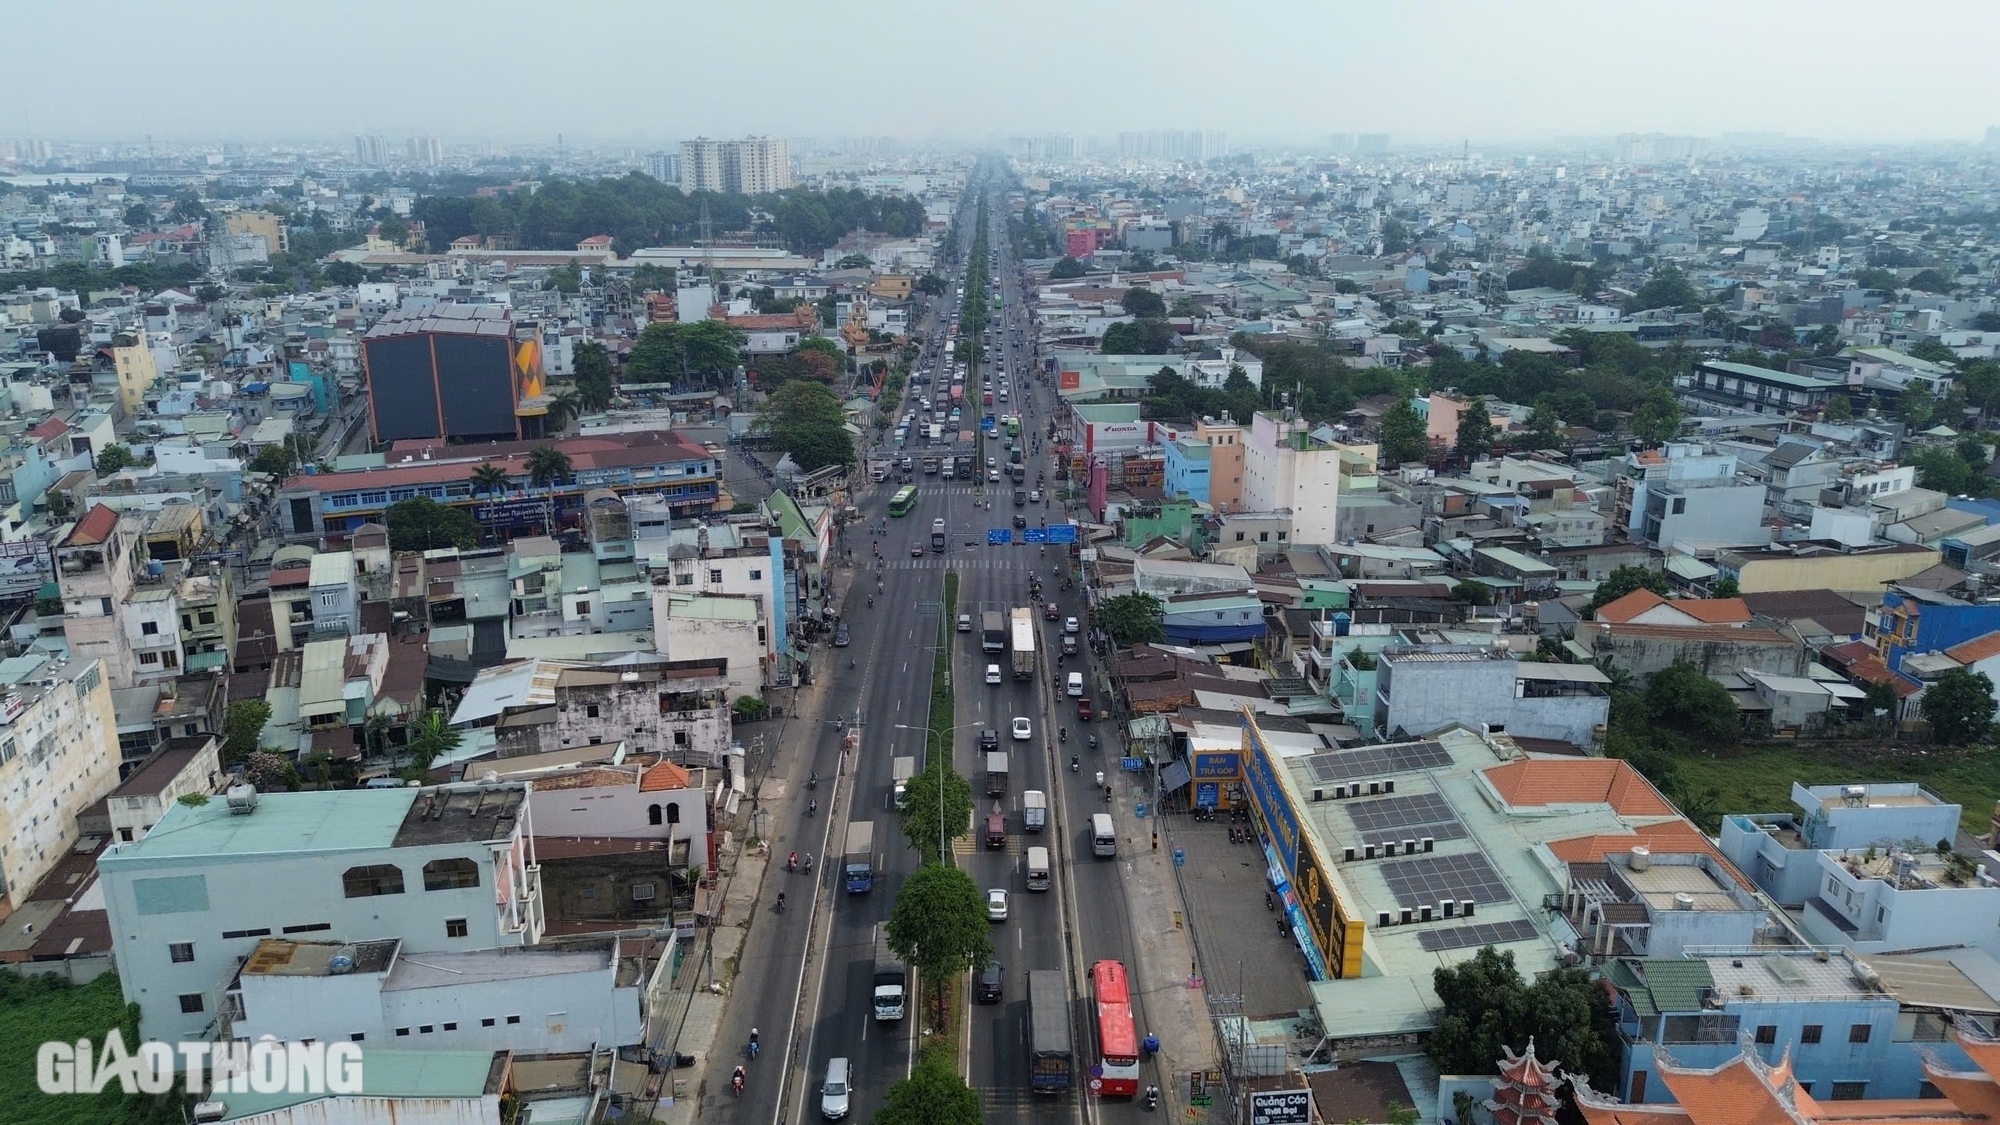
(11, 8, 2000, 1125)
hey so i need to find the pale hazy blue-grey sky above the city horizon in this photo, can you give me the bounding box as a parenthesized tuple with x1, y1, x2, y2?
(11, 0, 2000, 146)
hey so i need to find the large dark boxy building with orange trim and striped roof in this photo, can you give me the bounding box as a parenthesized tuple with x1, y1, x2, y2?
(362, 304, 522, 444)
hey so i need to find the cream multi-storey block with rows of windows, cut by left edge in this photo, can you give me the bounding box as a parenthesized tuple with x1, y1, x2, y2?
(0, 655, 118, 907)
